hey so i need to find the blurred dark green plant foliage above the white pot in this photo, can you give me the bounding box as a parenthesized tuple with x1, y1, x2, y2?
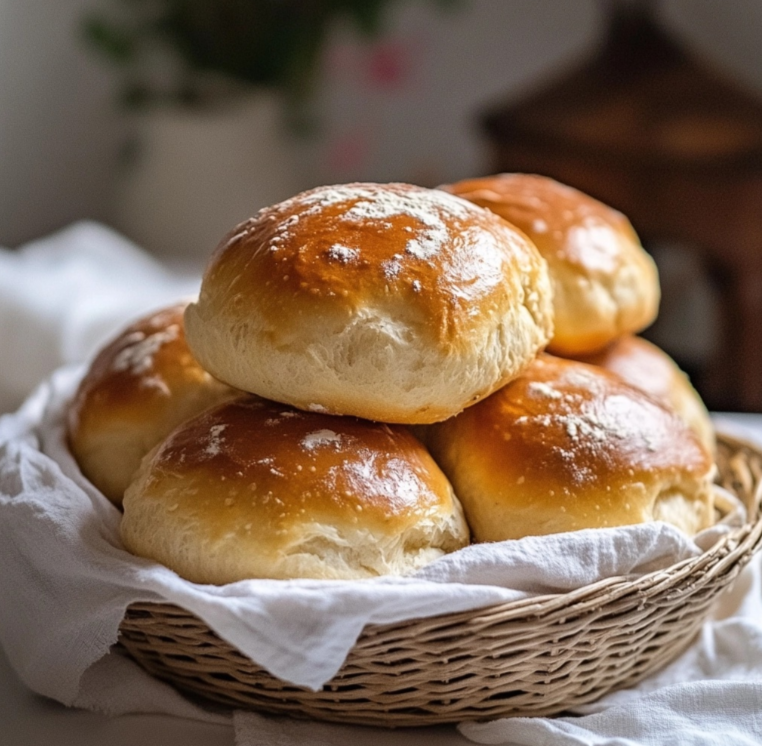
(83, 0, 463, 113)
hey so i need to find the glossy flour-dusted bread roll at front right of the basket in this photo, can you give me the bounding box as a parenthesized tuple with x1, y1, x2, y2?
(428, 355, 713, 541)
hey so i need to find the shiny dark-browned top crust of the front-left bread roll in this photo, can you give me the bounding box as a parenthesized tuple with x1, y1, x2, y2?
(145, 397, 460, 533)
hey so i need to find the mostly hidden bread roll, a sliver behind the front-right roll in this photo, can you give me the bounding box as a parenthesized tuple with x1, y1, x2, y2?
(578, 335, 715, 453)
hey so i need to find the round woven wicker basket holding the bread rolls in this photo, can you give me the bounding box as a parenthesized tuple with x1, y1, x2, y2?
(120, 436, 762, 727)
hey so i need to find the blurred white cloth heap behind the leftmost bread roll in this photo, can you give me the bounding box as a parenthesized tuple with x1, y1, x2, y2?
(0, 222, 199, 412)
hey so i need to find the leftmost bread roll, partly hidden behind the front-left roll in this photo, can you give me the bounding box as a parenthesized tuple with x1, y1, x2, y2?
(68, 303, 236, 505)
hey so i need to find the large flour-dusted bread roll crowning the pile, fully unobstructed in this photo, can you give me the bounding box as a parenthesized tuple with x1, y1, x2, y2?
(185, 184, 552, 423)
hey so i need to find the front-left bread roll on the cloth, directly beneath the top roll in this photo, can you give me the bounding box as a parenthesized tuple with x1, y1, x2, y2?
(121, 397, 469, 584)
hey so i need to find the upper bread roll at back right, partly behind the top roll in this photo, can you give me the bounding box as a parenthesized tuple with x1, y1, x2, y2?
(442, 174, 659, 357)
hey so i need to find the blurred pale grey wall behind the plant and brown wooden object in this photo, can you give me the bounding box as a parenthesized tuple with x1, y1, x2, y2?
(0, 0, 762, 246)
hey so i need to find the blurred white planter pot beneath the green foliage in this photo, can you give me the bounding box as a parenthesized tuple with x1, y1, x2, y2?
(112, 92, 305, 266)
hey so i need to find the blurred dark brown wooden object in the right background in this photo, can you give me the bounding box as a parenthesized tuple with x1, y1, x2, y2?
(483, 2, 762, 411)
